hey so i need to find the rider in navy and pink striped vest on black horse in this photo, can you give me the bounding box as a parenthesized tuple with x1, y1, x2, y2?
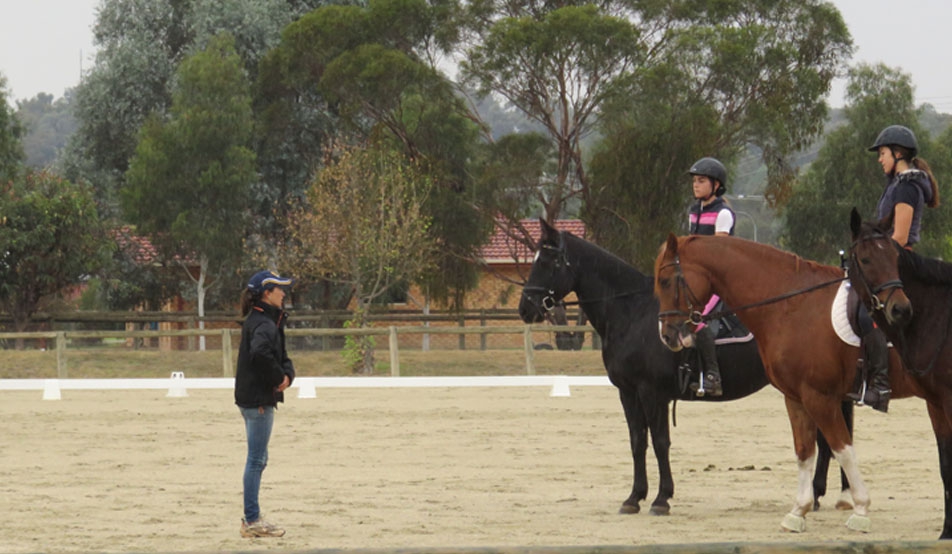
(688, 158, 735, 396)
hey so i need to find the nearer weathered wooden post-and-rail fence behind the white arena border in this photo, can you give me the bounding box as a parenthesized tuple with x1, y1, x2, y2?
(0, 324, 599, 379)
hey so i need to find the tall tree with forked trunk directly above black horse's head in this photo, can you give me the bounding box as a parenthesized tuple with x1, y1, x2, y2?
(460, 0, 648, 221)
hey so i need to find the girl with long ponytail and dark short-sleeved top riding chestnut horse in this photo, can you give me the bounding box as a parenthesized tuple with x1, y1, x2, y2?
(849, 125, 939, 412)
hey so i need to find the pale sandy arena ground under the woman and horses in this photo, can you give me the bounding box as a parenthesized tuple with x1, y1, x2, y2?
(0, 387, 942, 552)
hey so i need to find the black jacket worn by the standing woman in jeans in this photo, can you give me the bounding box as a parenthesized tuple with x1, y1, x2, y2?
(235, 302, 294, 408)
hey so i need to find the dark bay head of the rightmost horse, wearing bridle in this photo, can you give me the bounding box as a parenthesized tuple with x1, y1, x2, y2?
(849, 208, 912, 326)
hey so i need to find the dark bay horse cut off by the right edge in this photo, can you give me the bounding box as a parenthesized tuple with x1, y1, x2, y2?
(849, 209, 952, 539)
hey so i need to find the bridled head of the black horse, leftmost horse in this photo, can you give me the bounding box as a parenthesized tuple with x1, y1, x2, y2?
(519, 219, 575, 323)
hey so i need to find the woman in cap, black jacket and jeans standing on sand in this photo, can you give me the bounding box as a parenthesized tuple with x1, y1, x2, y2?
(235, 271, 294, 537)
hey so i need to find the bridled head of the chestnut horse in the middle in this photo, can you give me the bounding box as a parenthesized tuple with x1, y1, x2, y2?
(655, 233, 712, 352)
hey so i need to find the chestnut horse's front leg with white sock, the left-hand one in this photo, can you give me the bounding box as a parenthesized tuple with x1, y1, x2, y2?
(780, 396, 816, 533)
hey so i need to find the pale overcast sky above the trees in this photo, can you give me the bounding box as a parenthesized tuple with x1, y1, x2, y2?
(0, 0, 952, 113)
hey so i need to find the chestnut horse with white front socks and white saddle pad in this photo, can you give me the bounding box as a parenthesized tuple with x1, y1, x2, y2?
(654, 235, 912, 532)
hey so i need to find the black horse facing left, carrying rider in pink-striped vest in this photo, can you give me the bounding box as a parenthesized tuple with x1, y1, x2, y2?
(519, 220, 853, 515)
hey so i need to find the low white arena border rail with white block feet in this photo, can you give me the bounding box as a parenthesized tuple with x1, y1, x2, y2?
(0, 372, 611, 400)
